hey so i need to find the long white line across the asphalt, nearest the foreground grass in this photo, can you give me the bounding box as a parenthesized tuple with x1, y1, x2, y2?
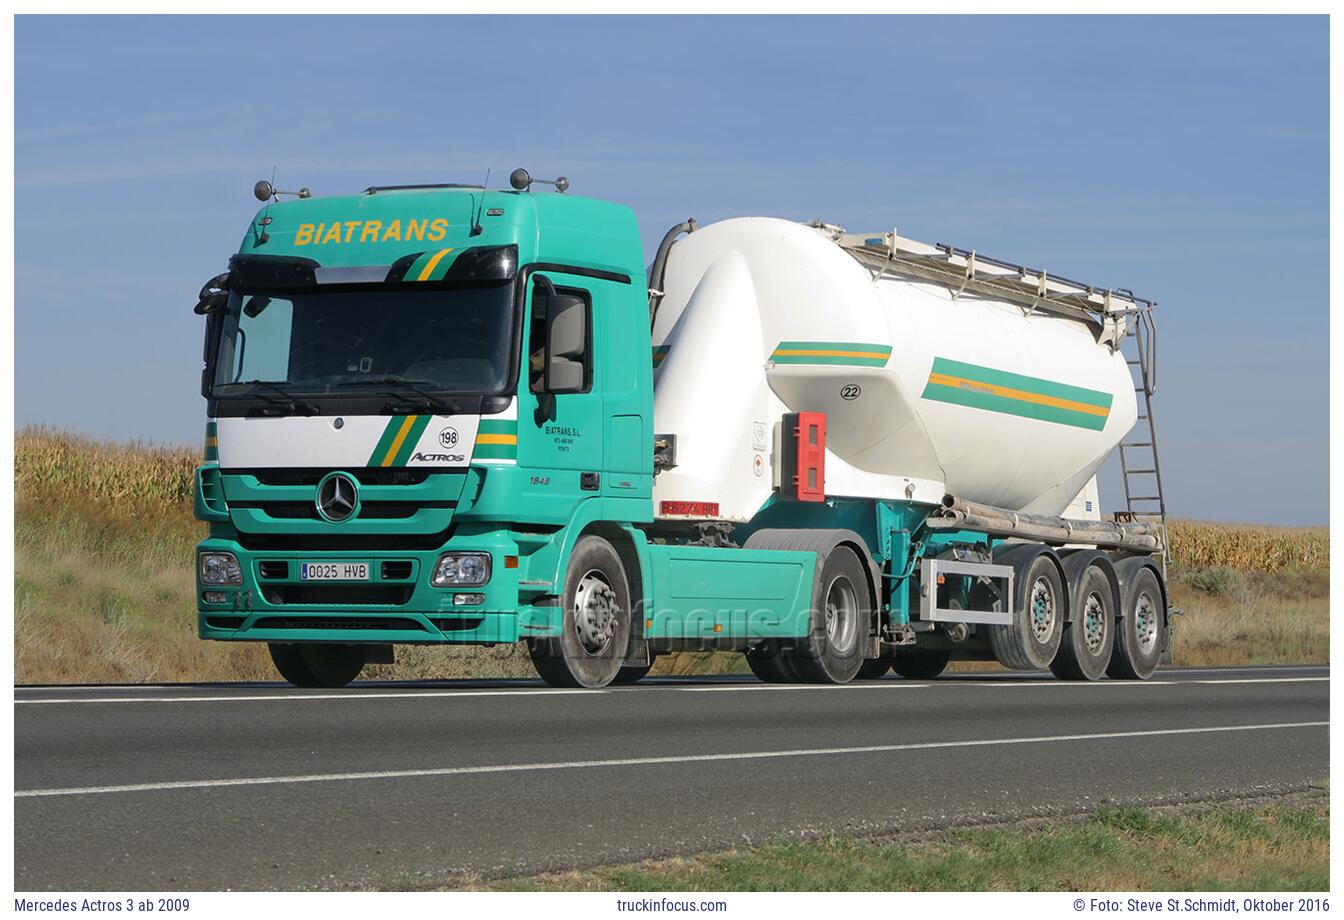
(13, 721, 1329, 799)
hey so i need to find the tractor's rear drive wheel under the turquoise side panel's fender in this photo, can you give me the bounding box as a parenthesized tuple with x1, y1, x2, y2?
(793, 547, 872, 684)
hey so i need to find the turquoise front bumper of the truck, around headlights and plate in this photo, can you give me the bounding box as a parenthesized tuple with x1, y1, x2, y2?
(196, 531, 560, 645)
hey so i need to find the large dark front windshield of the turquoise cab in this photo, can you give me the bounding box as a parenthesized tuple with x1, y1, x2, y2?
(211, 281, 513, 398)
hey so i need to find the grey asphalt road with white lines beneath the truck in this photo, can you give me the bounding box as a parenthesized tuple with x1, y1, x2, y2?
(15, 668, 1329, 892)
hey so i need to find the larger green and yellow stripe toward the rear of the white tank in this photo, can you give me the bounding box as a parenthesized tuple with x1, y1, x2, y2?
(923, 357, 1114, 431)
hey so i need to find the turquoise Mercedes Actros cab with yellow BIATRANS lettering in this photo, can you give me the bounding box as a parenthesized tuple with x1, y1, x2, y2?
(196, 179, 677, 676)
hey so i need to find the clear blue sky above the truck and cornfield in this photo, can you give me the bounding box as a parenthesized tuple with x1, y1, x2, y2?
(15, 16, 1329, 524)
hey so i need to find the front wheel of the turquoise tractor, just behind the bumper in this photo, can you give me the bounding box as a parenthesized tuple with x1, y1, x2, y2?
(527, 535, 630, 688)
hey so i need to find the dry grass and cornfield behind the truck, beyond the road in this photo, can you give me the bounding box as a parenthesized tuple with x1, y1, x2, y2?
(15, 428, 1329, 684)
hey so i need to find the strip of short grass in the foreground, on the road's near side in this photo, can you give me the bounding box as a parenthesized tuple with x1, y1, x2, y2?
(388, 794, 1329, 891)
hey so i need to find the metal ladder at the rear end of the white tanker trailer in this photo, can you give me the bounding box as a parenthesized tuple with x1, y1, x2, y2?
(1117, 304, 1171, 566)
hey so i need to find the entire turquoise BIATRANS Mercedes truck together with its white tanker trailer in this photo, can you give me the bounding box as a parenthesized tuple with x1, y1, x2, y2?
(195, 169, 1171, 688)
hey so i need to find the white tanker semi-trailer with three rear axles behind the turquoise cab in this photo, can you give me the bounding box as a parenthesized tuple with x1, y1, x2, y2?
(652, 218, 1169, 680)
